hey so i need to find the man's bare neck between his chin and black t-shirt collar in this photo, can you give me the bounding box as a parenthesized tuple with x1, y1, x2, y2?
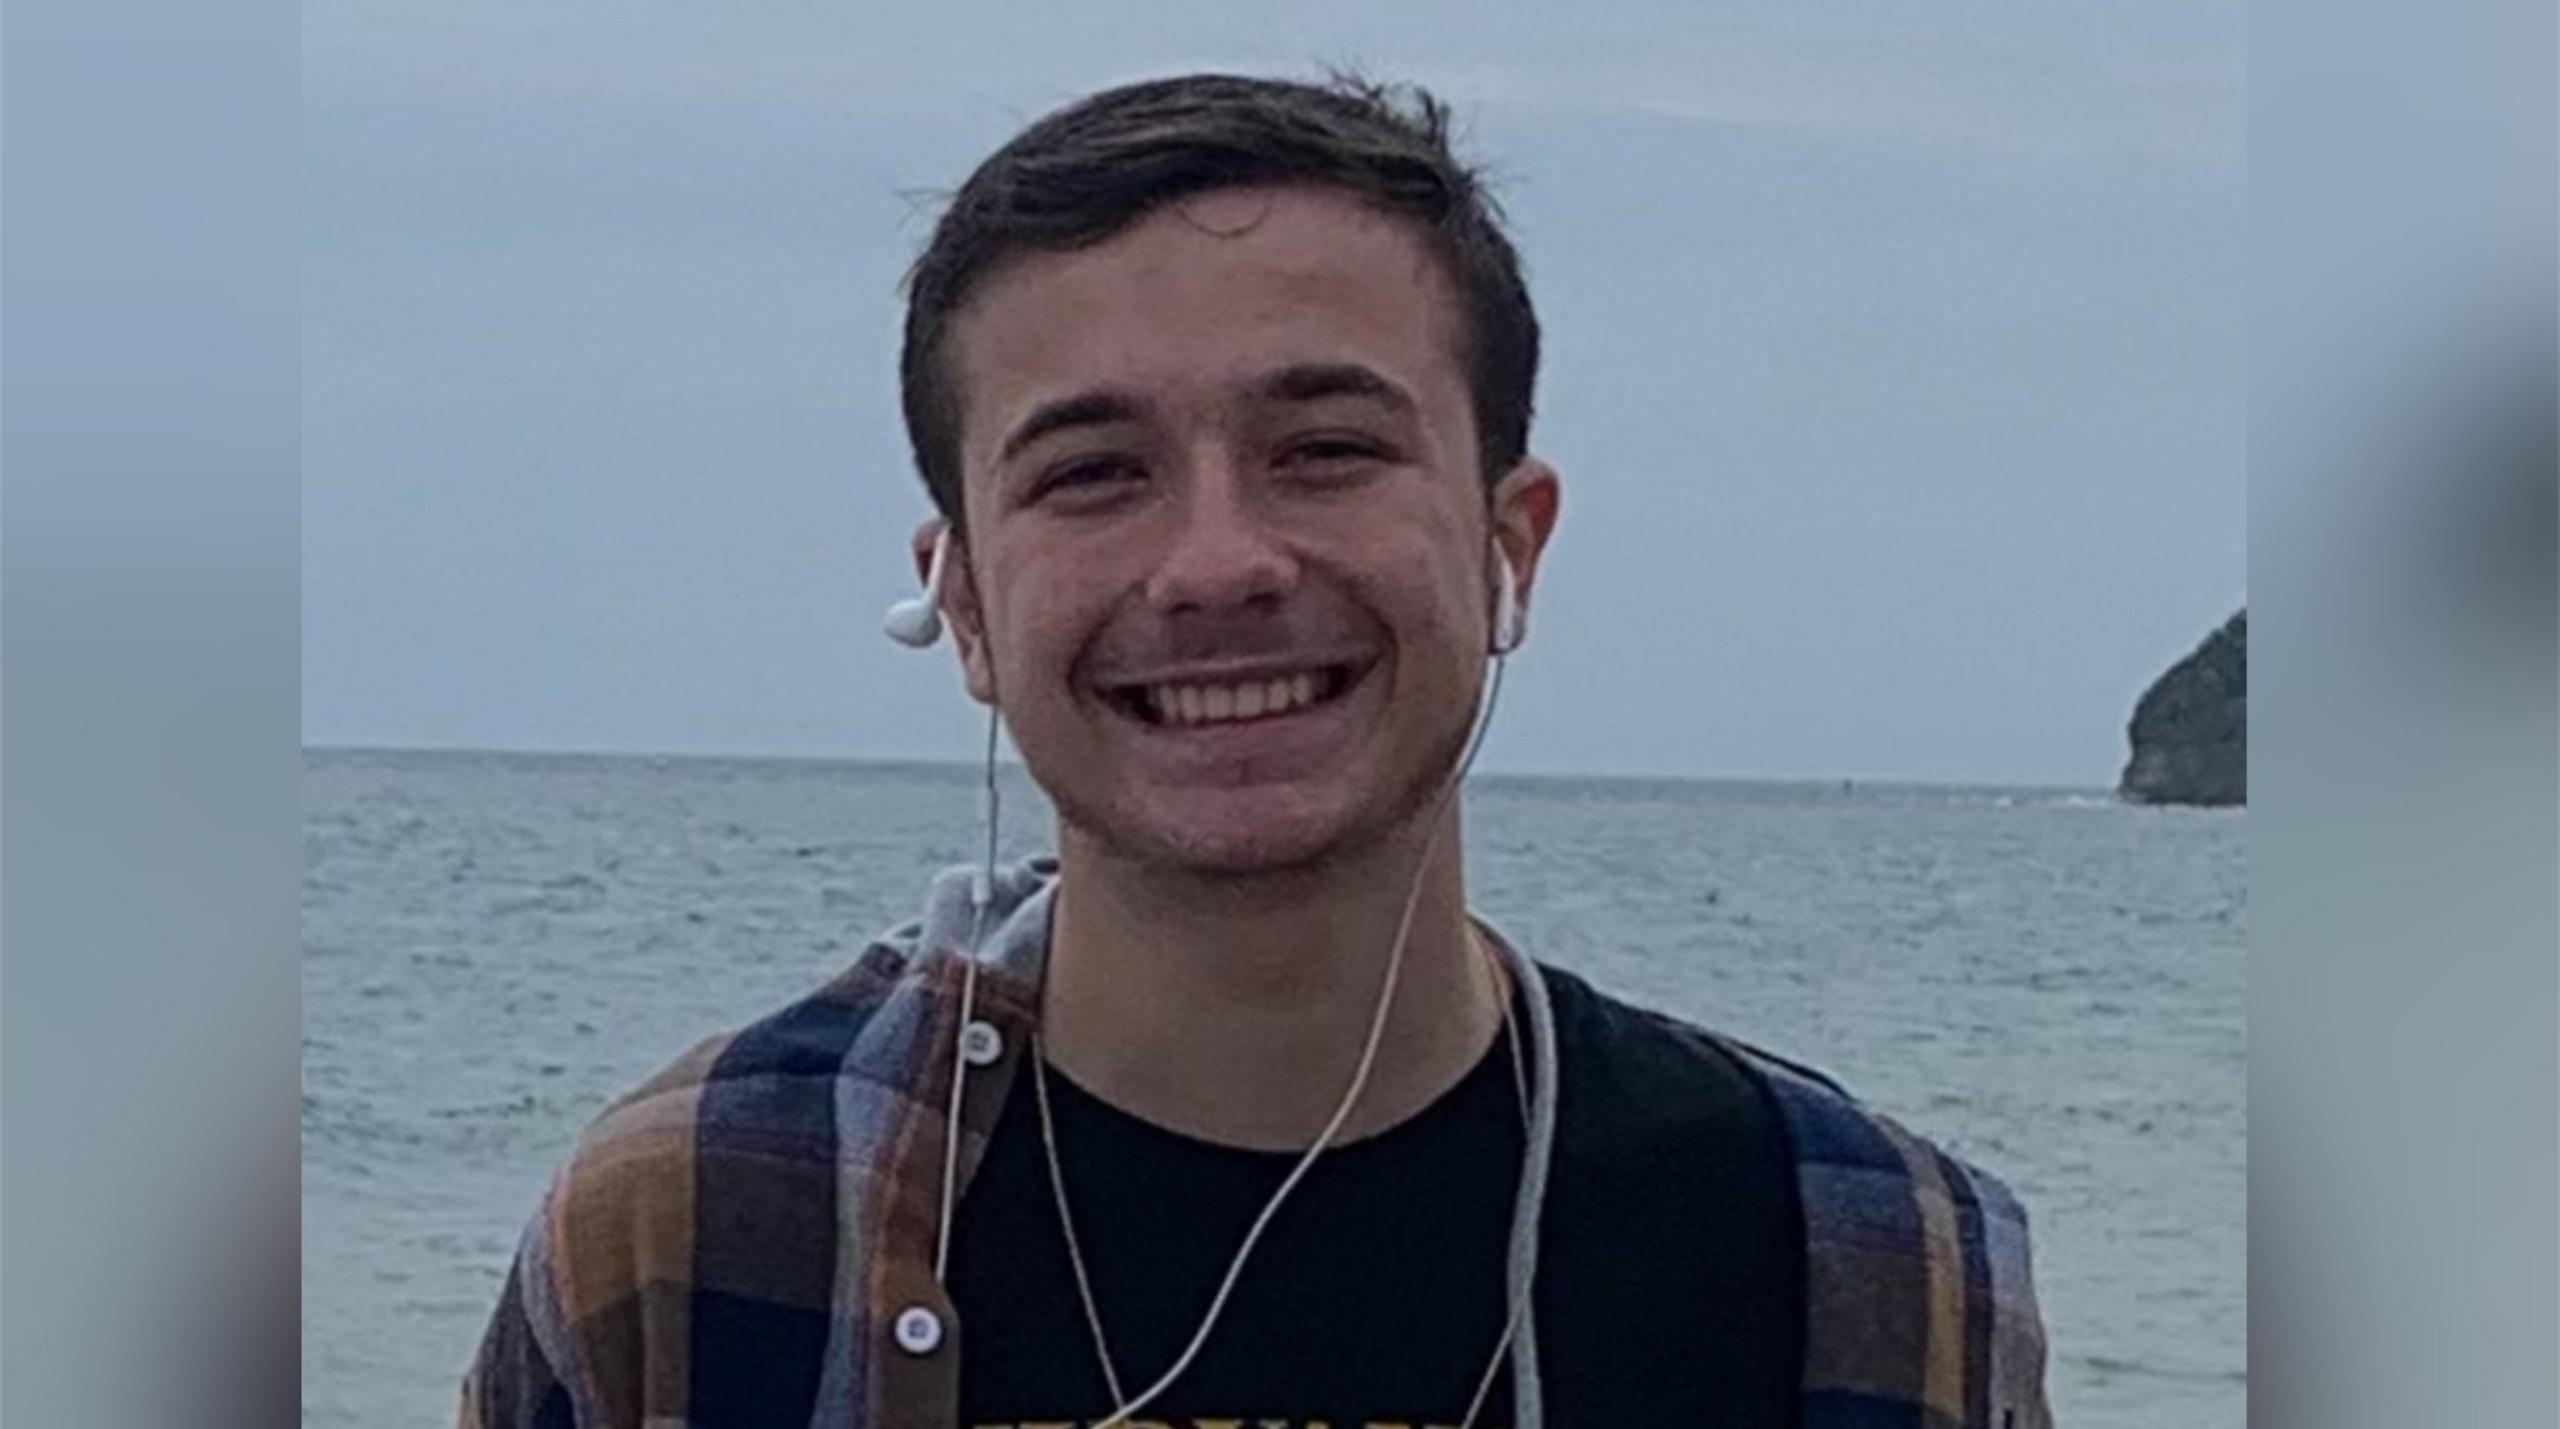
(1042, 799, 1505, 1150)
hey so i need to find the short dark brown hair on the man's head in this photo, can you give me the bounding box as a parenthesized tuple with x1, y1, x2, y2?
(899, 74, 1539, 525)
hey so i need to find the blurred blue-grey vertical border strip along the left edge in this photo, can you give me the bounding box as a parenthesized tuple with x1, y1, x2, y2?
(0, 0, 300, 1429)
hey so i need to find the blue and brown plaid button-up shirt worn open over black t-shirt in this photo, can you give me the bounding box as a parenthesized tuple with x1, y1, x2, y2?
(461, 860, 2051, 1429)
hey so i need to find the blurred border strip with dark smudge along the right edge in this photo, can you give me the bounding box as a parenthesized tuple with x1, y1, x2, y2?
(2250, 0, 2560, 1426)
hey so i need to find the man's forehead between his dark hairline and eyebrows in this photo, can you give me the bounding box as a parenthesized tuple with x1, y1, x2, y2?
(950, 187, 1464, 453)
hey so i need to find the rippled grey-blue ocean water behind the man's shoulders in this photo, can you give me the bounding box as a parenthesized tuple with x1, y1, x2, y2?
(302, 750, 2248, 1429)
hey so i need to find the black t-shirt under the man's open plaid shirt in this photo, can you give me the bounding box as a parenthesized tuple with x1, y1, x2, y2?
(950, 968, 1805, 1429)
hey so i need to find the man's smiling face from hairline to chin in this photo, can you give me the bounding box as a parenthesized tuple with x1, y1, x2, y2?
(950, 187, 1556, 873)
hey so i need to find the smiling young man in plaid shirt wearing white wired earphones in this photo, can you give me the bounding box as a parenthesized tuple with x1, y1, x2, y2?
(463, 77, 2048, 1429)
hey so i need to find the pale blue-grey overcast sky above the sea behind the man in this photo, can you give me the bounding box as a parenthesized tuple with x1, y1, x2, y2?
(302, 0, 2245, 784)
